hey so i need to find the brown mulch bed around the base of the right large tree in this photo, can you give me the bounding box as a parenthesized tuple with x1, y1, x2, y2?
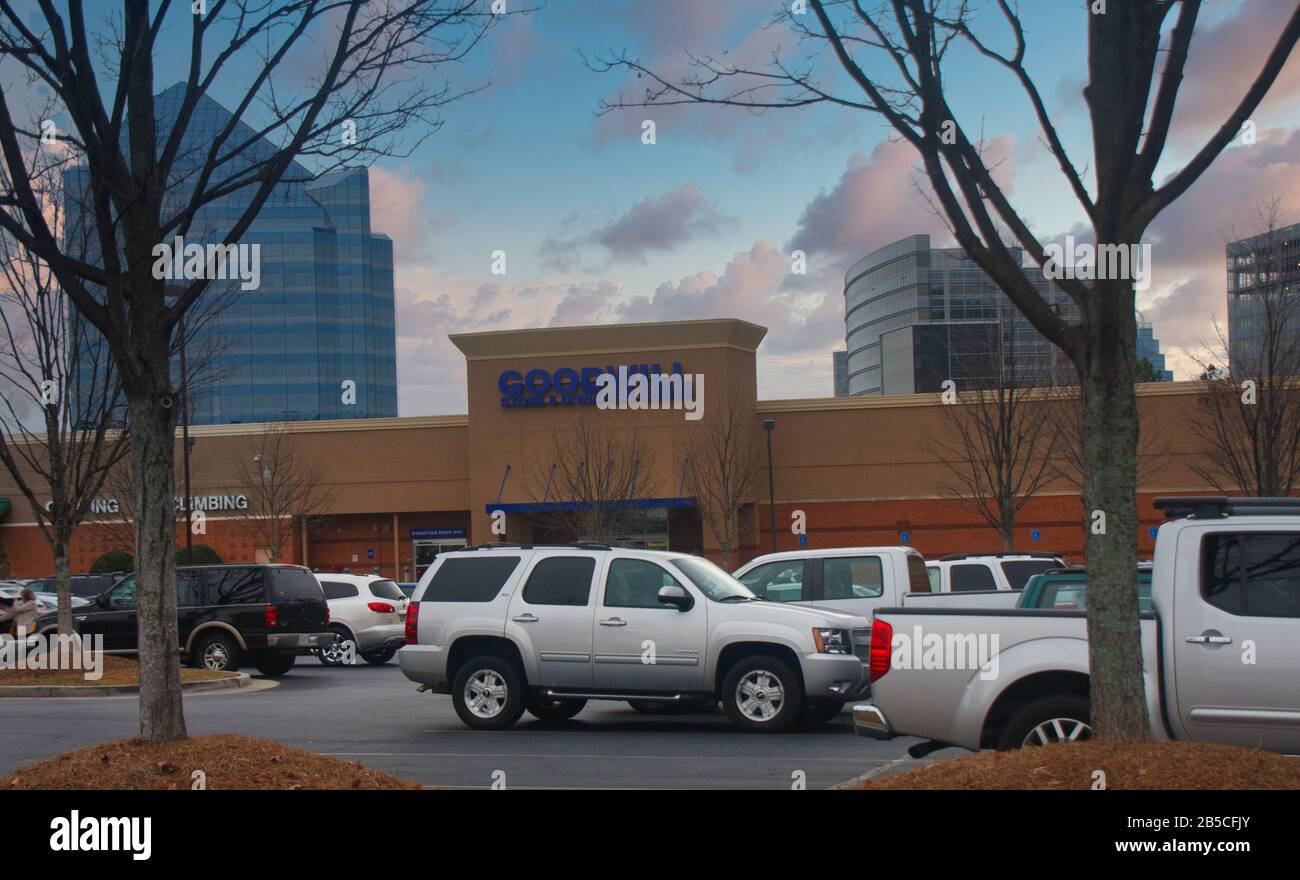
(849, 742, 1300, 792)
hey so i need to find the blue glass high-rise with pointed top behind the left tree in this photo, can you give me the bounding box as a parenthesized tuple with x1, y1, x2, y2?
(65, 83, 398, 424)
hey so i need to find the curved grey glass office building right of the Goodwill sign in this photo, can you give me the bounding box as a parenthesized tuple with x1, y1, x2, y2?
(844, 235, 1078, 395)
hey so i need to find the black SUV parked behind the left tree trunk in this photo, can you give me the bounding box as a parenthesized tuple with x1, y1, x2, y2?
(36, 565, 334, 676)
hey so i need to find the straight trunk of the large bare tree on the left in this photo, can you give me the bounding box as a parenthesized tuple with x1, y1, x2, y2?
(127, 392, 186, 742)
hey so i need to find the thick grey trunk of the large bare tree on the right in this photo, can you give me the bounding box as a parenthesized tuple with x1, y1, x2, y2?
(1080, 298, 1148, 740)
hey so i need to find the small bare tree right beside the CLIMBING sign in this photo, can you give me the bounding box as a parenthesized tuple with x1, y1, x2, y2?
(234, 424, 338, 563)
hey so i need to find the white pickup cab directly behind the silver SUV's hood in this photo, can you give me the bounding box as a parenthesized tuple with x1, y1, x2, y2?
(735, 547, 930, 617)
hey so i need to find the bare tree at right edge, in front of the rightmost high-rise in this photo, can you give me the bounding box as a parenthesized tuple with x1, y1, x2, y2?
(1191, 199, 1300, 497)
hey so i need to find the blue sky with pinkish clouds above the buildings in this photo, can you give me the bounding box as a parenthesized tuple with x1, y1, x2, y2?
(7, 0, 1300, 416)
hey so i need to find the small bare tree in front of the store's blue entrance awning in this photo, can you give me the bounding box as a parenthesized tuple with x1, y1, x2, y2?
(527, 408, 654, 543)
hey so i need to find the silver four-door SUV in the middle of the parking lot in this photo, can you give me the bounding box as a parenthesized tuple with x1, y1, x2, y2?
(398, 545, 871, 732)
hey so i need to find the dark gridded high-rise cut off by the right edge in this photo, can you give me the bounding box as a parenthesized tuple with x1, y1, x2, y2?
(1227, 224, 1300, 372)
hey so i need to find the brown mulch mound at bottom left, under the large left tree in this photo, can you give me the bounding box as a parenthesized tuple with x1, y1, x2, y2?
(0, 733, 420, 792)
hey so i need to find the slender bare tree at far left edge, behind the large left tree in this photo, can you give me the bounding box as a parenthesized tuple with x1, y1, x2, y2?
(0, 149, 127, 634)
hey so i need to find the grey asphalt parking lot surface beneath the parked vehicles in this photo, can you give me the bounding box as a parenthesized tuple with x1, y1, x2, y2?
(0, 658, 935, 789)
